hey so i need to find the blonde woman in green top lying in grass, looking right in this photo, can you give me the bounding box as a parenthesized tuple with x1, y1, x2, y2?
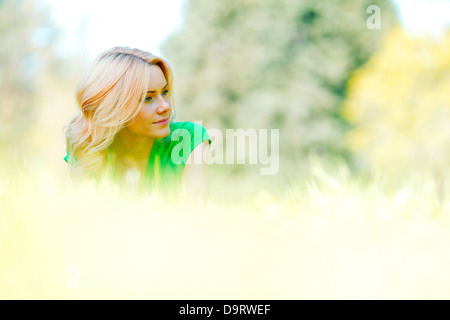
(64, 47, 211, 198)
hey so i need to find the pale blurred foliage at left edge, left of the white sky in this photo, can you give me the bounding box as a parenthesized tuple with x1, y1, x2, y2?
(0, 0, 59, 154)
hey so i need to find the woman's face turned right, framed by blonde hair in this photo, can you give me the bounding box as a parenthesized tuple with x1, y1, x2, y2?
(126, 65, 172, 138)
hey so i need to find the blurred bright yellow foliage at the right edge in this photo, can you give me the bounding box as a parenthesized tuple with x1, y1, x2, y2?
(342, 29, 450, 174)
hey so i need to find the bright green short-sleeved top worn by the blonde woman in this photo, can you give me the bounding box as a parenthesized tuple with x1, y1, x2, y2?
(64, 121, 211, 190)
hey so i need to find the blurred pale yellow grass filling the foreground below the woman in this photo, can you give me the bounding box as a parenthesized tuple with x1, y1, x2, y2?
(0, 159, 450, 299)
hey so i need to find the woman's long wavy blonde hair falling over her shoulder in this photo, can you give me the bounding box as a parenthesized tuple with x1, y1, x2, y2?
(64, 47, 175, 178)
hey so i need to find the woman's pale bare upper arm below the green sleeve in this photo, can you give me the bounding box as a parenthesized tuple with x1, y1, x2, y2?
(181, 140, 209, 200)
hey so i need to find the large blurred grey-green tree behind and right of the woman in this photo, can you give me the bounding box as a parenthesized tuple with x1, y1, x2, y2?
(162, 0, 396, 169)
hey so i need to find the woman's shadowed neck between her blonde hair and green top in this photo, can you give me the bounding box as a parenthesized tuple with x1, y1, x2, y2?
(112, 128, 155, 159)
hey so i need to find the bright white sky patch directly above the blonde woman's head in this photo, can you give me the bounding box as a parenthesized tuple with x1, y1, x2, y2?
(41, 0, 183, 57)
